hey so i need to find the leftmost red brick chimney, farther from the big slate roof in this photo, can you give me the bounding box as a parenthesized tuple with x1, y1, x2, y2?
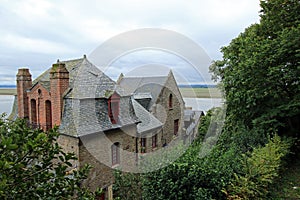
(17, 69, 32, 118)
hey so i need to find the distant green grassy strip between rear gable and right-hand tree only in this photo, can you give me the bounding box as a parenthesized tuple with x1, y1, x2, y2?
(179, 88, 221, 98)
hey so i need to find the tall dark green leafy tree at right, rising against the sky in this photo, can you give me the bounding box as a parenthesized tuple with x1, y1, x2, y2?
(210, 0, 300, 137)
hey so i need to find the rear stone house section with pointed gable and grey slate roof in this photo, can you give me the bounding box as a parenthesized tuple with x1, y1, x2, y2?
(118, 71, 185, 149)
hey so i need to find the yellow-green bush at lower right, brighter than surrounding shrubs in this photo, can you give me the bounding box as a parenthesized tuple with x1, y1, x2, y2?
(223, 135, 291, 199)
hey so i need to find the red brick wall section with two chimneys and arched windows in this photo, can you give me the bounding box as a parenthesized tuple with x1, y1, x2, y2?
(17, 63, 69, 131)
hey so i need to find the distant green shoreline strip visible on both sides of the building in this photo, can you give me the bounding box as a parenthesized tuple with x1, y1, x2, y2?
(0, 88, 222, 98)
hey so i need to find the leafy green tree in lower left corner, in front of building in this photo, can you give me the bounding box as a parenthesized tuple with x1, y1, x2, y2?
(0, 115, 101, 199)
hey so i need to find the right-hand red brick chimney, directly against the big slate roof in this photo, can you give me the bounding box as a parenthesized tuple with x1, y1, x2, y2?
(50, 61, 69, 126)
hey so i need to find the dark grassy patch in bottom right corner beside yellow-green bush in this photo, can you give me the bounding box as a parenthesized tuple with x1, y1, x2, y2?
(270, 154, 300, 199)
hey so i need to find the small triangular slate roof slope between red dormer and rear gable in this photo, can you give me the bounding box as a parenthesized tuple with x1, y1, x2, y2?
(132, 99, 163, 134)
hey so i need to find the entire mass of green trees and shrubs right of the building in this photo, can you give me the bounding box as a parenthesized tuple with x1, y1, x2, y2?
(114, 0, 300, 200)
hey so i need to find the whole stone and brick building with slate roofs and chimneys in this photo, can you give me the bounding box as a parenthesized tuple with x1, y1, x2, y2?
(11, 56, 184, 197)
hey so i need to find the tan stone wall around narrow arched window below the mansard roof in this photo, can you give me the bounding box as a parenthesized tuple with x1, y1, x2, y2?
(79, 125, 136, 190)
